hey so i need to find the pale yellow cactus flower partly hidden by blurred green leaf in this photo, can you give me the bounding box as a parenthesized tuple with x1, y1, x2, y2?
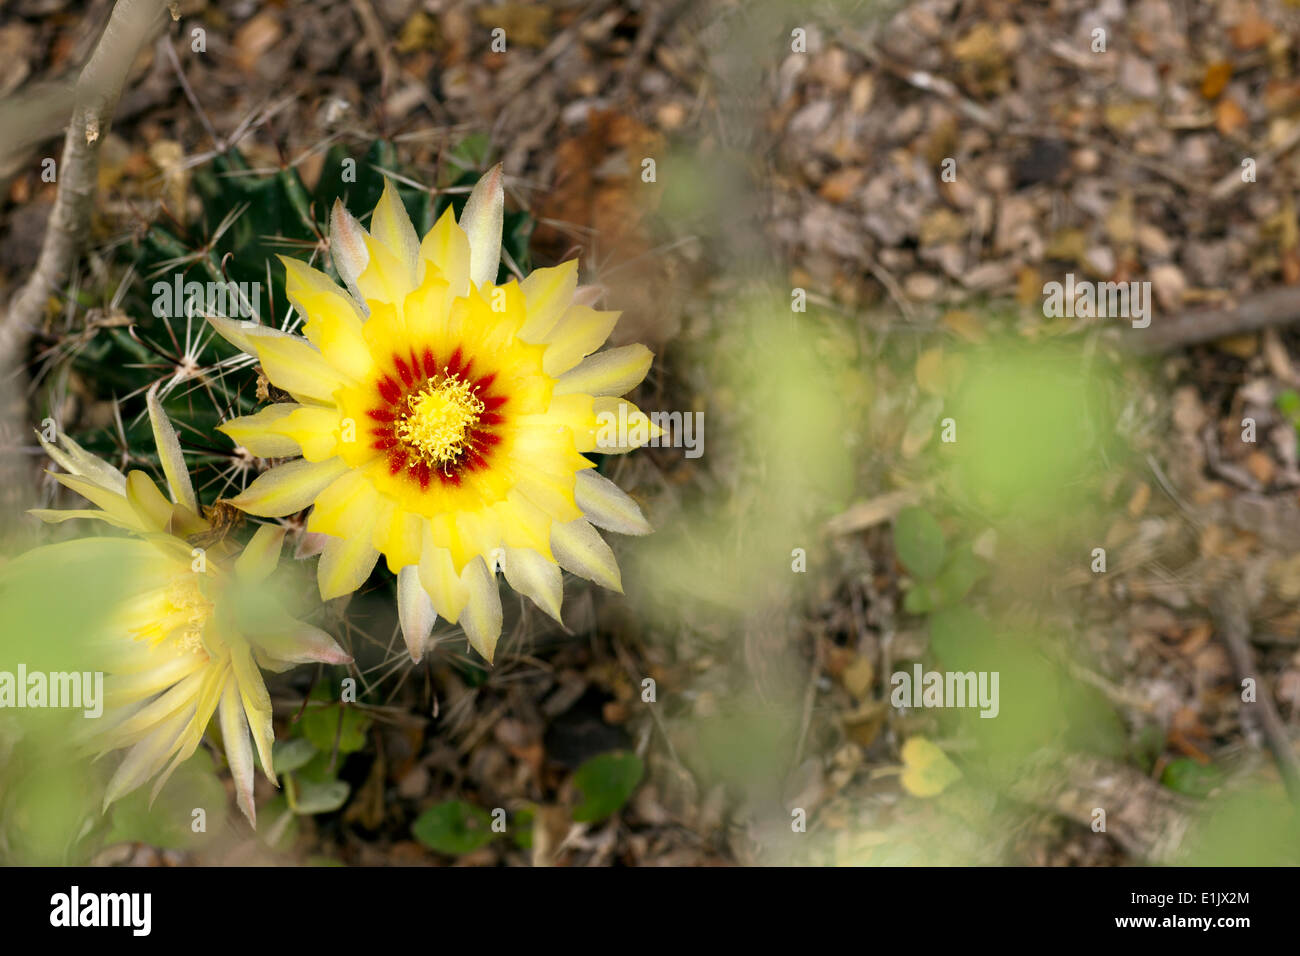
(33, 392, 351, 825)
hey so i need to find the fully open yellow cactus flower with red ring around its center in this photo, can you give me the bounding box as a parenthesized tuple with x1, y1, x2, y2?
(217, 166, 659, 662)
